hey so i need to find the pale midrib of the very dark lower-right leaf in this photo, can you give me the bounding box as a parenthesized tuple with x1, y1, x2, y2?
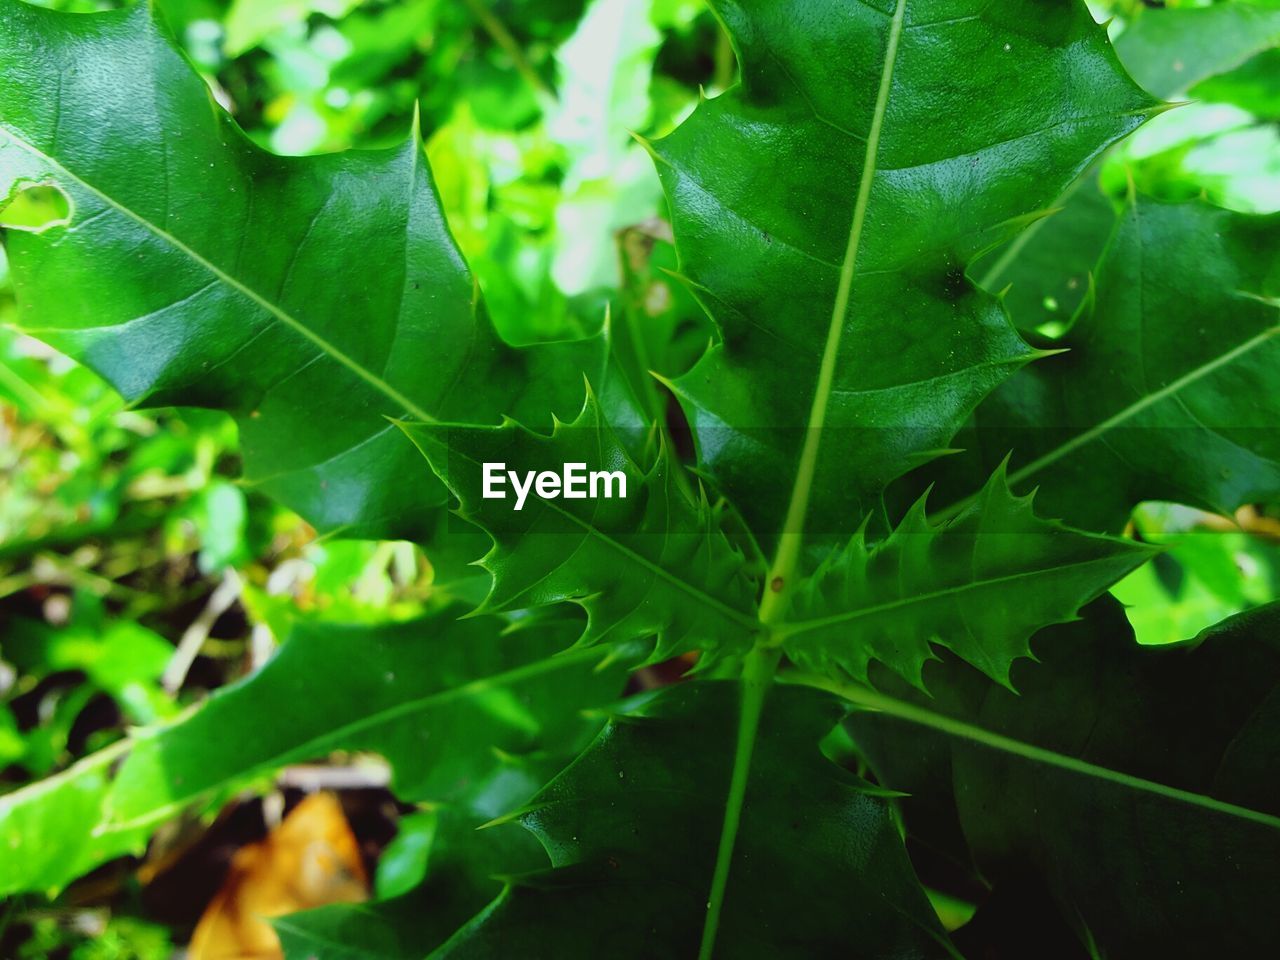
(795, 675, 1280, 829)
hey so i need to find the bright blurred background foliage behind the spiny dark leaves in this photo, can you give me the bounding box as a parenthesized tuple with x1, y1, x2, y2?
(0, 0, 1280, 960)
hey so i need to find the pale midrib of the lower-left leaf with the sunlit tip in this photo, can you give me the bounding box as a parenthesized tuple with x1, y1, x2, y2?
(99, 648, 607, 833)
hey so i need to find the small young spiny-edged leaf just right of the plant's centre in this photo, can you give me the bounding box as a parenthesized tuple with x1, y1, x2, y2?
(777, 468, 1153, 686)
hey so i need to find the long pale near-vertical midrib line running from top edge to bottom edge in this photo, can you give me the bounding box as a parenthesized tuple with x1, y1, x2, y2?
(698, 0, 906, 960)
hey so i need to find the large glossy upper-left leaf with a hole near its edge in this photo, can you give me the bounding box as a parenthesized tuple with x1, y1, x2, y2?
(0, 0, 605, 540)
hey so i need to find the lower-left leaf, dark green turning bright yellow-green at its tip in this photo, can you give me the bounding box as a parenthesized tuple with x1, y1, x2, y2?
(0, 611, 622, 893)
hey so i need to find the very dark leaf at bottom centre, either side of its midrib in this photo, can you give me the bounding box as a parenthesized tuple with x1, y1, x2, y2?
(433, 681, 952, 960)
